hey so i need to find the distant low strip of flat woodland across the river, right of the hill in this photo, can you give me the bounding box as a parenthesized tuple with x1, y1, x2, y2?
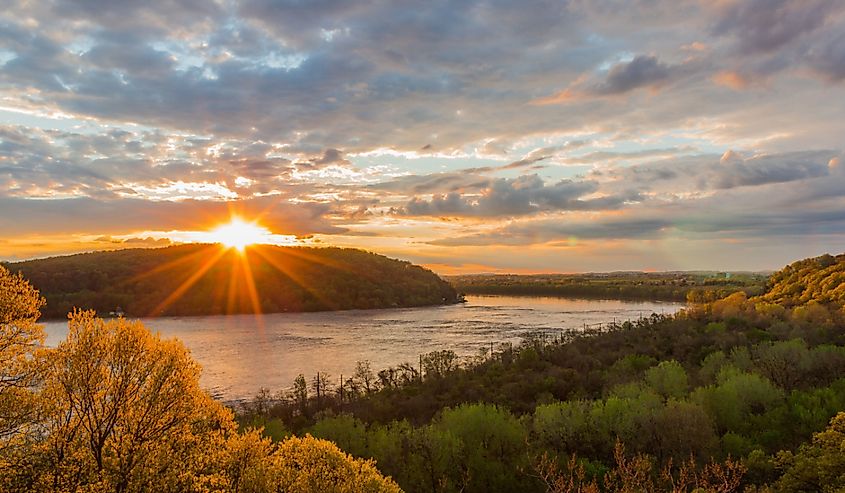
(446, 272, 768, 303)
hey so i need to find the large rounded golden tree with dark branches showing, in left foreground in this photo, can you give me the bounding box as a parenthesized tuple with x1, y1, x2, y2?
(28, 311, 235, 492)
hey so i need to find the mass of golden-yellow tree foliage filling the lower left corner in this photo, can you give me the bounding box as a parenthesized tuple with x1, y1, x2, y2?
(0, 274, 400, 493)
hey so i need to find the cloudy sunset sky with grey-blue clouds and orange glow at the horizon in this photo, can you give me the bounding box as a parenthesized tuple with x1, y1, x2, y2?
(0, 0, 845, 274)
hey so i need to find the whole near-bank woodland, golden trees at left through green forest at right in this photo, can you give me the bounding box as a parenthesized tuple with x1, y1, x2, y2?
(0, 255, 845, 493)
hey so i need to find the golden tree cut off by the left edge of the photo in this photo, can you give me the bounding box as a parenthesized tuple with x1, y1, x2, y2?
(0, 266, 44, 458)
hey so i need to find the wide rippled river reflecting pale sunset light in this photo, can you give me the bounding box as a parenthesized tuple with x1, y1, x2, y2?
(44, 296, 683, 401)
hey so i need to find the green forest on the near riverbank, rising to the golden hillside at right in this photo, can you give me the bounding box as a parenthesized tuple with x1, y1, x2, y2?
(234, 256, 845, 492)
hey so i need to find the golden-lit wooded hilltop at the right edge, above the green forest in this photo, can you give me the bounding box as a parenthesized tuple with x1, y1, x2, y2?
(760, 254, 845, 307)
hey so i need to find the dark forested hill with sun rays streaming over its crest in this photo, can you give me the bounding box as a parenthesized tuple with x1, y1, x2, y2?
(5, 244, 458, 318)
